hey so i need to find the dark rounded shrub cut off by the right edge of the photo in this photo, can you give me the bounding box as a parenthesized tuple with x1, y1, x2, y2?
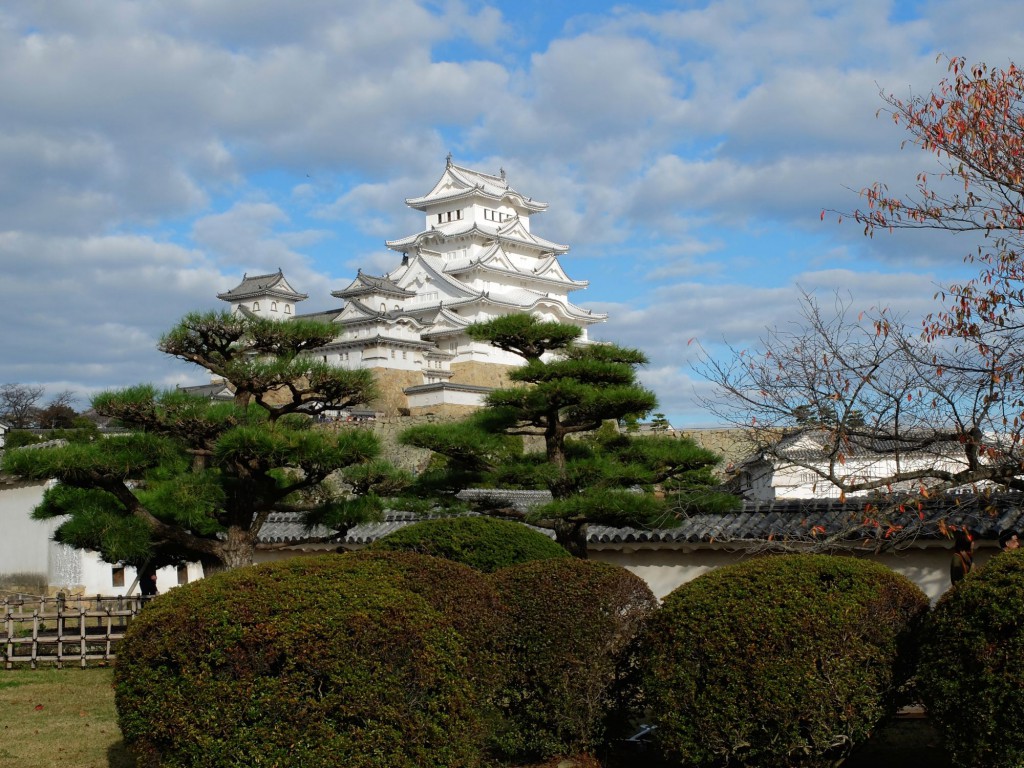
(918, 550, 1024, 768)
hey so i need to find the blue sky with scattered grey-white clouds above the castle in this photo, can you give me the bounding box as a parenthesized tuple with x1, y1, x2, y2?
(0, 0, 1024, 427)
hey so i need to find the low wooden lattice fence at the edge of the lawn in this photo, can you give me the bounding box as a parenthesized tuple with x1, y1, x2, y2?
(0, 595, 144, 670)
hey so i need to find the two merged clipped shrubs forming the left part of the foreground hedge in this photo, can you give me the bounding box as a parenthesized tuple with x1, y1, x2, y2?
(115, 552, 656, 768)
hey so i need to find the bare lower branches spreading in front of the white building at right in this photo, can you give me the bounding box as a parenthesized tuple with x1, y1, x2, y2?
(698, 294, 1024, 503)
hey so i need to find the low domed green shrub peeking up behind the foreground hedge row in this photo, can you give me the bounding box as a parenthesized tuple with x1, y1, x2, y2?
(371, 516, 569, 573)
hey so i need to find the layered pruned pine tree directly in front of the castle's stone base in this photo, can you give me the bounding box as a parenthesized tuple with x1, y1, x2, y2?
(401, 315, 737, 557)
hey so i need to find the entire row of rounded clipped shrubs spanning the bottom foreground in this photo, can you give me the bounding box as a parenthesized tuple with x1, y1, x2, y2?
(116, 540, 1024, 768)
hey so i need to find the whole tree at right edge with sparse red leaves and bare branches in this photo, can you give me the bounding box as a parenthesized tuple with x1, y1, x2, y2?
(701, 57, 1024, 532)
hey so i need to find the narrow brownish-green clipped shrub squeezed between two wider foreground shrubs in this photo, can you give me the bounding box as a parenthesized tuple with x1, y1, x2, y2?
(492, 558, 657, 760)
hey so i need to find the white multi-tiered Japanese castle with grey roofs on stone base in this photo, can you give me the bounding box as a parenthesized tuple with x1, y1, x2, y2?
(212, 156, 607, 415)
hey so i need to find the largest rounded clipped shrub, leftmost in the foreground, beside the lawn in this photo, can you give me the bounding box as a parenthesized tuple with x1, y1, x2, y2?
(115, 555, 485, 768)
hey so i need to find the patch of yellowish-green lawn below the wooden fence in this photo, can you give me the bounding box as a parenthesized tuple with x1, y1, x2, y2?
(0, 668, 135, 768)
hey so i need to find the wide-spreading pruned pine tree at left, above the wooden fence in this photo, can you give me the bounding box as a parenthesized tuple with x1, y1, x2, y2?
(3, 312, 408, 568)
